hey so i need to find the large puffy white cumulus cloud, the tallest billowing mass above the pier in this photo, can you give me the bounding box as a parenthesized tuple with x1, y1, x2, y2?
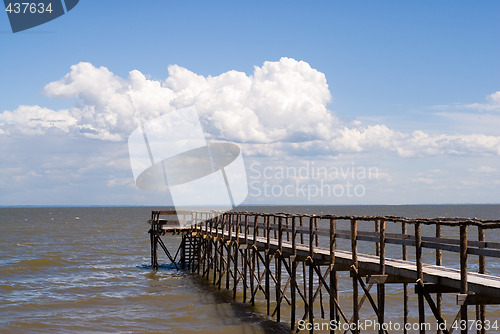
(38, 58, 337, 143)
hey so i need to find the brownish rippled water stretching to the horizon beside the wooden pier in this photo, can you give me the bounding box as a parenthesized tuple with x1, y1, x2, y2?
(0, 205, 500, 333)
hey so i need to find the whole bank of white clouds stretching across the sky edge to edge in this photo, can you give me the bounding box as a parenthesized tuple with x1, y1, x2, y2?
(0, 58, 500, 157)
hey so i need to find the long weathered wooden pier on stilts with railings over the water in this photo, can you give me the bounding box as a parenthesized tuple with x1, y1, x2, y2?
(149, 211, 500, 333)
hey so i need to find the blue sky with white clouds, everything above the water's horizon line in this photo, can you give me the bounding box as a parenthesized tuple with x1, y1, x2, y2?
(0, 0, 500, 205)
